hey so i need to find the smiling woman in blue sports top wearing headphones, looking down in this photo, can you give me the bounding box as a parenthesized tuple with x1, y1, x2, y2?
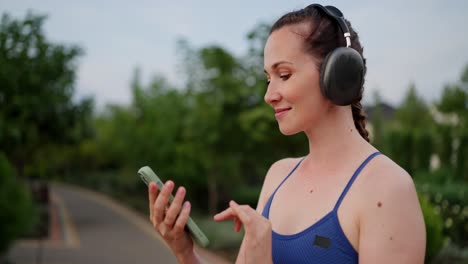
(149, 4, 425, 264)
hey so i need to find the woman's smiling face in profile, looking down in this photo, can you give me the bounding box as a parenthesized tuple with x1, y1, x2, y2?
(264, 25, 329, 135)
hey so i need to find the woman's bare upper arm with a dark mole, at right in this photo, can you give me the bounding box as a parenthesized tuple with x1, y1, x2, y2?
(359, 164, 426, 264)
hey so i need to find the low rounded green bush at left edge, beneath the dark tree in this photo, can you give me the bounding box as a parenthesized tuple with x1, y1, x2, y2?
(0, 152, 35, 256)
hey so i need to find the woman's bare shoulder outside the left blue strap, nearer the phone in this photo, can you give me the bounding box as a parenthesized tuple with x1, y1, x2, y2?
(257, 158, 302, 211)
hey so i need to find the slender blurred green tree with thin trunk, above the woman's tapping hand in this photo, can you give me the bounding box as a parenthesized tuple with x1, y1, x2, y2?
(180, 43, 247, 213)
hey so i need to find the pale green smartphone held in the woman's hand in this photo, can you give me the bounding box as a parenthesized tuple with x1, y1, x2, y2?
(138, 166, 210, 247)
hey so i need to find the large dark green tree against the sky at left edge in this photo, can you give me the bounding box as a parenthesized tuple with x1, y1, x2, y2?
(0, 13, 93, 176)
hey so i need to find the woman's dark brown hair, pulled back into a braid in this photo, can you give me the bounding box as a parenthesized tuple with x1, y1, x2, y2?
(270, 6, 369, 141)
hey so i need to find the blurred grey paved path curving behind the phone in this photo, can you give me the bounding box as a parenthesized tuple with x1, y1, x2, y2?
(8, 184, 229, 264)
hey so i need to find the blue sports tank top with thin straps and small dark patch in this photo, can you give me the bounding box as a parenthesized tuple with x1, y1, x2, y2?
(262, 152, 380, 264)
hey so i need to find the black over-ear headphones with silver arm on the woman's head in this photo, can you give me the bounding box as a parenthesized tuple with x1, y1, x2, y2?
(307, 4, 364, 106)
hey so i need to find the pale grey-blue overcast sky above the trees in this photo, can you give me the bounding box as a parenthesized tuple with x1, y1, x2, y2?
(0, 0, 468, 107)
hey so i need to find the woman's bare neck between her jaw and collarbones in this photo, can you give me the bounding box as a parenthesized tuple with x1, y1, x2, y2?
(305, 106, 368, 162)
